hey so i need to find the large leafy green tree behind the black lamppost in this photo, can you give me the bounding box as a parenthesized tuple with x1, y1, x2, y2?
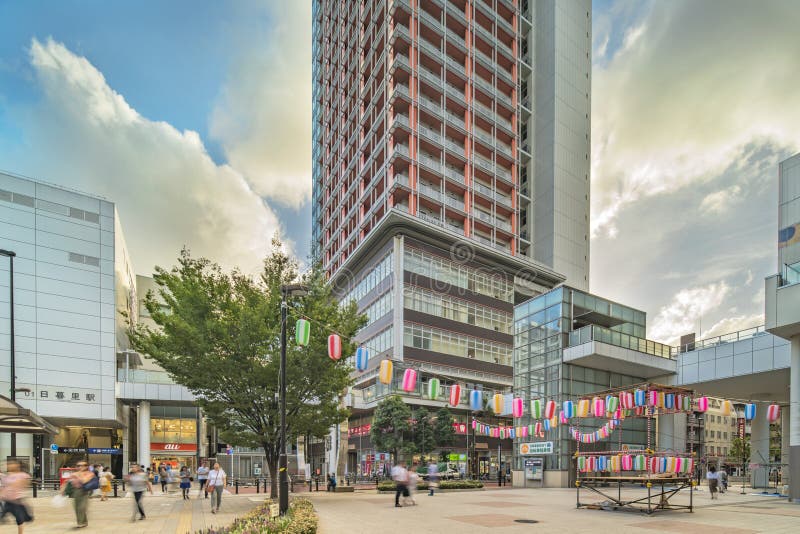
(129, 238, 365, 497)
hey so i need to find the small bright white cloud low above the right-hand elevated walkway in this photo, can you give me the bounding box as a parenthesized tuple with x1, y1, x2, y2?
(647, 282, 731, 345)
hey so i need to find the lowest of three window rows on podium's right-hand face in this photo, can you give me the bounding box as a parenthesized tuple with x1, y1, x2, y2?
(403, 323, 511, 365)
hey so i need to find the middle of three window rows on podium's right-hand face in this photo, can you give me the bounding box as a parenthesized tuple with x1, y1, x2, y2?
(403, 286, 511, 334)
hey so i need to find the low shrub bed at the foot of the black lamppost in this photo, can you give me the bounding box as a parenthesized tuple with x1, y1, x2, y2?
(197, 498, 318, 534)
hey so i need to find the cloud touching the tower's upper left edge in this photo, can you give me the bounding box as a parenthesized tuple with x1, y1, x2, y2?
(210, 0, 311, 207)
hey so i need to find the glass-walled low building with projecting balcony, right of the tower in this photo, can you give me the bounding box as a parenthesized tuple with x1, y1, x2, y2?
(514, 286, 674, 486)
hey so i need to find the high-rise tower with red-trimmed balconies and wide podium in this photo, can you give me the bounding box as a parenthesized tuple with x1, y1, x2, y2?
(311, 0, 591, 478)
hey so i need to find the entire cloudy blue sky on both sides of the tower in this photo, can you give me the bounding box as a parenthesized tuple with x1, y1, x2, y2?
(0, 0, 800, 344)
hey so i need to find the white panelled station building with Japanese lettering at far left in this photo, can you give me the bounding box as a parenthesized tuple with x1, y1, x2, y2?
(0, 173, 137, 475)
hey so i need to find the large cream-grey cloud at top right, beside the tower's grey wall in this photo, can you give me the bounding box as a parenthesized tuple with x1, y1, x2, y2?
(592, 0, 800, 235)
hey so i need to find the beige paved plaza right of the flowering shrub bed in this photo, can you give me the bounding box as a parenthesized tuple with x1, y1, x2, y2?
(310, 489, 800, 534)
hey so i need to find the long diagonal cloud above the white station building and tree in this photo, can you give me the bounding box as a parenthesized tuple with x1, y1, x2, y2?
(10, 39, 280, 273)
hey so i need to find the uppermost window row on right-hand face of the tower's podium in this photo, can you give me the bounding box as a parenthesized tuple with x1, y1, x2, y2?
(404, 248, 514, 302)
